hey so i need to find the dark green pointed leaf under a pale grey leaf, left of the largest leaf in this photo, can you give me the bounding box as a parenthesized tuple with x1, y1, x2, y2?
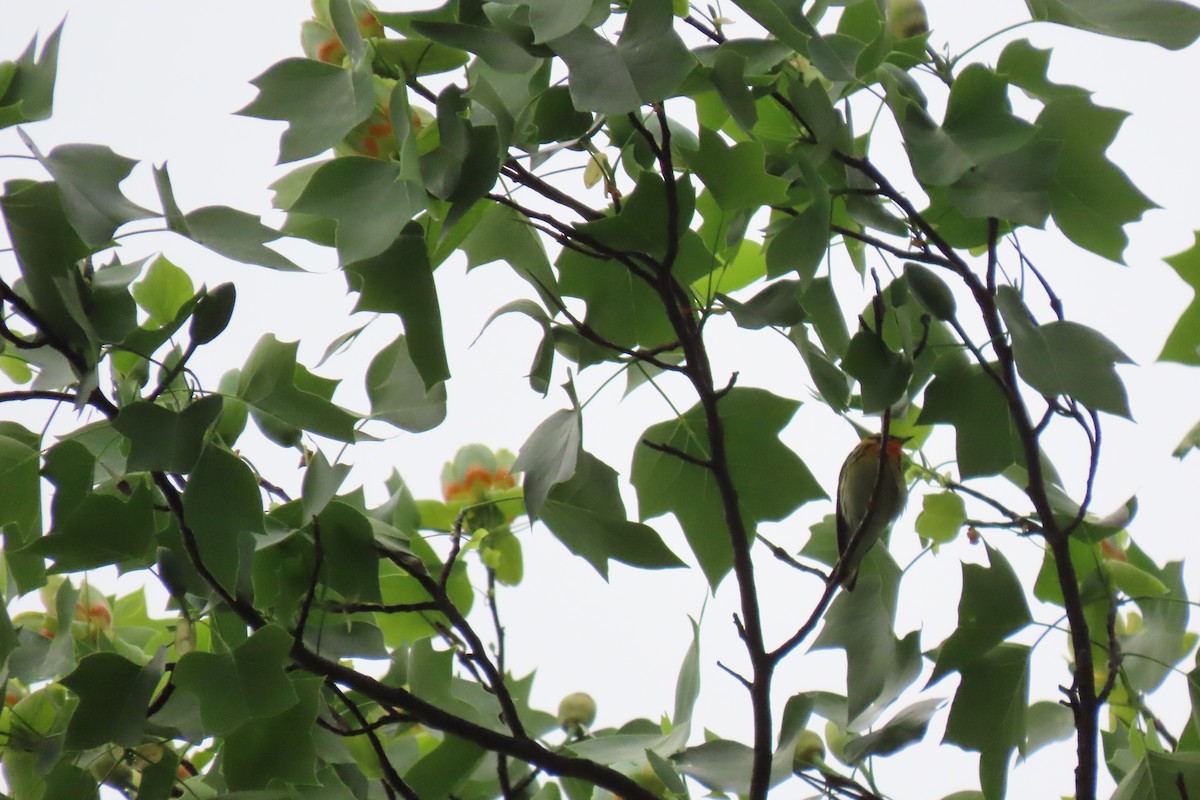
(537, 452, 684, 578)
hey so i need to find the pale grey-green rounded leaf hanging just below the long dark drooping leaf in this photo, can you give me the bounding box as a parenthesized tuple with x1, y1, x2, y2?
(366, 336, 446, 433)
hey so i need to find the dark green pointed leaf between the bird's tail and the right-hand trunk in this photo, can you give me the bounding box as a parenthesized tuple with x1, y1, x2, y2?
(929, 545, 1033, 684)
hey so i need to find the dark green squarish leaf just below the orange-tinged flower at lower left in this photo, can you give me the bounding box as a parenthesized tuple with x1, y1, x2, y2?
(61, 650, 166, 750)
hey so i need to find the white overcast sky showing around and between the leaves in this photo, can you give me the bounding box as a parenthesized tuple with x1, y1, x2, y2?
(0, 0, 1200, 798)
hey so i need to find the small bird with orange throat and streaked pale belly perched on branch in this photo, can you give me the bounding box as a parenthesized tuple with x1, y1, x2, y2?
(835, 433, 908, 591)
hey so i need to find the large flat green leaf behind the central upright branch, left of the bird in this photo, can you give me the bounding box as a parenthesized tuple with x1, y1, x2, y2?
(631, 387, 824, 589)
